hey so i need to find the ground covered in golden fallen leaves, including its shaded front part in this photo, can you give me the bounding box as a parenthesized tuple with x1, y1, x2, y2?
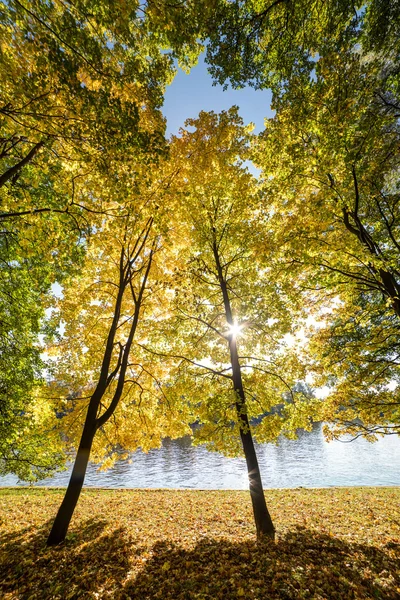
(0, 488, 400, 600)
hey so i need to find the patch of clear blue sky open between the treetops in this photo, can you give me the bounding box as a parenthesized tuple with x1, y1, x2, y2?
(163, 56, 273, 137)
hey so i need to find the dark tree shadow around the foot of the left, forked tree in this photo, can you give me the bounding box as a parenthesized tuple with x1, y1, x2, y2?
(0, 518, 130, 600)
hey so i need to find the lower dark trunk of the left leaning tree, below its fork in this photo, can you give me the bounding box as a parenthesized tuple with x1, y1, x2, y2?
(47, 421, 96, 546)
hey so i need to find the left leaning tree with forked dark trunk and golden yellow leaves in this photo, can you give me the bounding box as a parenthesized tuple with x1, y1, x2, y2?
(43, 150, 197, 545)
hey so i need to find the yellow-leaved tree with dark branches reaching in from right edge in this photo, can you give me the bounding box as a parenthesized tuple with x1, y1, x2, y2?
(250, 47, 400, 434)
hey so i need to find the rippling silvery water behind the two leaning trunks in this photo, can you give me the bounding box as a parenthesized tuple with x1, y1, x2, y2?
(0, 426, 400, 489)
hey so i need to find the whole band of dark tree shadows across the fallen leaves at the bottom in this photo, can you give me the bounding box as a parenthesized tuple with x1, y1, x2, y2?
(0, 518, 400, 600)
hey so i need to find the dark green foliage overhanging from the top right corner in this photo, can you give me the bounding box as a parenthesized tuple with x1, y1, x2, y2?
(199, 0, 399, 96)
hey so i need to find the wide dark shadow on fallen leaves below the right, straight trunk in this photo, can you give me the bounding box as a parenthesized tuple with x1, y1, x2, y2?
(123, 529, 400, 600)
